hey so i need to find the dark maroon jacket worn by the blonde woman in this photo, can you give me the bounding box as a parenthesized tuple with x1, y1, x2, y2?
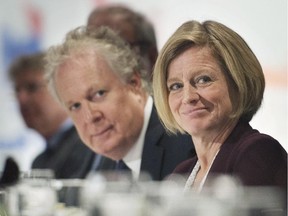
(174, 122, 287, 188)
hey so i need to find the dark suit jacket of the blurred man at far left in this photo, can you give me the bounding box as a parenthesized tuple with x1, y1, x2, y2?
(32, 126, 95, 179)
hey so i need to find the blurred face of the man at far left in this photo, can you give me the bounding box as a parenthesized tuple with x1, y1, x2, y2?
(14, 70, 66, 137)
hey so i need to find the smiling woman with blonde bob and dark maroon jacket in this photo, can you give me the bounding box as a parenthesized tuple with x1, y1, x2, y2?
(153, 21, 287, 193)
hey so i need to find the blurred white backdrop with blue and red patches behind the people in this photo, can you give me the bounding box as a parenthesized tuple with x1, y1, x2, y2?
(0, 0, 288, 170)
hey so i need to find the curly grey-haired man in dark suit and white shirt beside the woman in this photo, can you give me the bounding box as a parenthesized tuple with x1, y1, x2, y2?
(46, 26, 194, 180)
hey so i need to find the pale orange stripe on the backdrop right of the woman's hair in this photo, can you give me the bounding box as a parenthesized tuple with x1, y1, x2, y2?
(264, 70, 287, 88)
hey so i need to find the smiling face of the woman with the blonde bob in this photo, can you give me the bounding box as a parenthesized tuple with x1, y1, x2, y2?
(167, 47, 232, 136)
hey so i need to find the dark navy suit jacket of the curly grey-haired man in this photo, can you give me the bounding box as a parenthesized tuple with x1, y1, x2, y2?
(93, 107, 195, 180)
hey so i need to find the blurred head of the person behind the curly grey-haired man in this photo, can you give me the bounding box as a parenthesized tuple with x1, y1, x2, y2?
(87, 4, 158, 78)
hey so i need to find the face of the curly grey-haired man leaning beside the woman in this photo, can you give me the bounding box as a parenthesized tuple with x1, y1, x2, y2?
(55, 55, 146, 160)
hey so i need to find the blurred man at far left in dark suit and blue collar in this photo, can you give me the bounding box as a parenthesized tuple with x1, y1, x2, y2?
(9, 52, 95, 178)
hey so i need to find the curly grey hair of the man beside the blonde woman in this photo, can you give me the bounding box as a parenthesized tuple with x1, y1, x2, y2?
(45, 26, 151, 102)
